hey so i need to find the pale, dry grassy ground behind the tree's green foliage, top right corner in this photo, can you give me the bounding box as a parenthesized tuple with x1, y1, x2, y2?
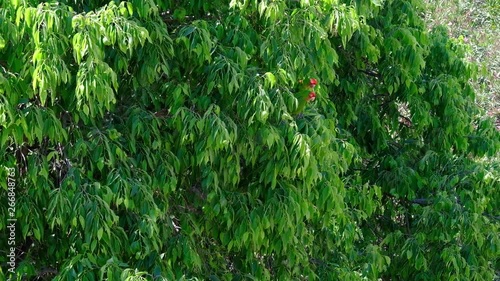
(425, 0, 500, 129)
